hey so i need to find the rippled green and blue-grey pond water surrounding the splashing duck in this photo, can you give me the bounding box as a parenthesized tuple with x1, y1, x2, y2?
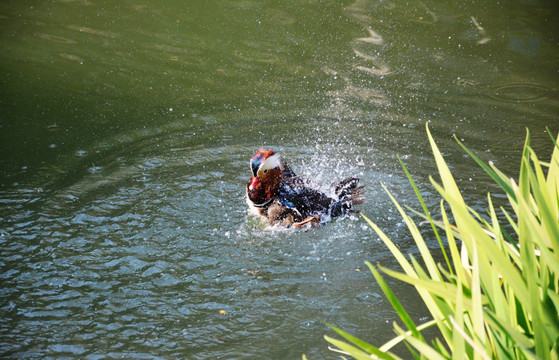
(0, 0, 559, 359)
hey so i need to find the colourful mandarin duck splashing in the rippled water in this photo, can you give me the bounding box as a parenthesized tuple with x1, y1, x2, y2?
(246, 148, 365, 227)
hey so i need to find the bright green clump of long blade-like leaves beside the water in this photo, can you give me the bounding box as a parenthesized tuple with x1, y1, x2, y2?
(316, 126, 559, 360)
